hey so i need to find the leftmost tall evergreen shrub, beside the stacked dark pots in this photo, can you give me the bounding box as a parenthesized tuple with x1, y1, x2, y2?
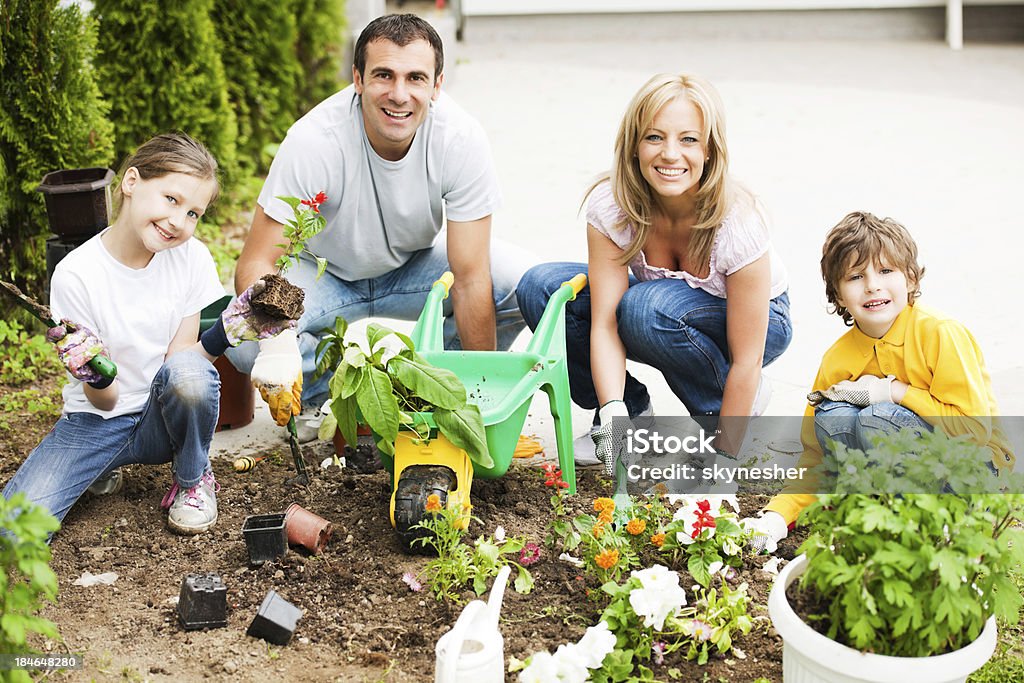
(0, 0, 114, 299)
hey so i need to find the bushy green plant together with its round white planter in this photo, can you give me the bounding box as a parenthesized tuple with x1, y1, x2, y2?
(768, 430, 1024, 683)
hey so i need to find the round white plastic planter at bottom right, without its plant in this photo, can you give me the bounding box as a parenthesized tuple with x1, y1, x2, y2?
(768, 555, 995, 683)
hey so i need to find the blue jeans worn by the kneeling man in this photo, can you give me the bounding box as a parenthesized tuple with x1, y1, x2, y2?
(226, 233, 537, 408)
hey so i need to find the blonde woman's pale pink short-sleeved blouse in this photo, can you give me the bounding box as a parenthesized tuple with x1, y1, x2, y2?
(587, 182, 788, 299)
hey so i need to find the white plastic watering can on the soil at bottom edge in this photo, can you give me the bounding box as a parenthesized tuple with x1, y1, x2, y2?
(434, 566, 512, 683)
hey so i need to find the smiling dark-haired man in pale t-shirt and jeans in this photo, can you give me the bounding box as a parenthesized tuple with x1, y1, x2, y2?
(229, 14, 532, 438)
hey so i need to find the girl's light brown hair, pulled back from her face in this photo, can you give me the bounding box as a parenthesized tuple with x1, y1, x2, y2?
(114, 132, 220, 217)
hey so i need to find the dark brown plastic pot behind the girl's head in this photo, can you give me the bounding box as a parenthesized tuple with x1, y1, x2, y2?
(36, 168, 114, 241)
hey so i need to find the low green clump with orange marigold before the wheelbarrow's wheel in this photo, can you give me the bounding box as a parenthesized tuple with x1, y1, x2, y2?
(413, 505, 539, 602)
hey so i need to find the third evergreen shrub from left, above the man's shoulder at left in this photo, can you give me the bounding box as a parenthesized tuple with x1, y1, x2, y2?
(212, 0, 301, 171)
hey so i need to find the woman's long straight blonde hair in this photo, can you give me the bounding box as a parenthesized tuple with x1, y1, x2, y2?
(584, 74, 754, 264)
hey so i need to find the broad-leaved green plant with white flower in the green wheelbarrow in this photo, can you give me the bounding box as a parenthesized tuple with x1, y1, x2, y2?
(316, 317, 495, 467)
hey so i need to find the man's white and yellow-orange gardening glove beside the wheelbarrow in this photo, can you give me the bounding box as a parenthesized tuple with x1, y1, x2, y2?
(251, 329, 302, 427)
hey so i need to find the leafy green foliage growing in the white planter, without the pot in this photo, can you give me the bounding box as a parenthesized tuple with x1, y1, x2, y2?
(800, 431, 1024, 656)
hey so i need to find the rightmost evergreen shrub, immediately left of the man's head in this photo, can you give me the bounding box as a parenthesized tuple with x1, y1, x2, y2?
(292, 0, 350, 117)
